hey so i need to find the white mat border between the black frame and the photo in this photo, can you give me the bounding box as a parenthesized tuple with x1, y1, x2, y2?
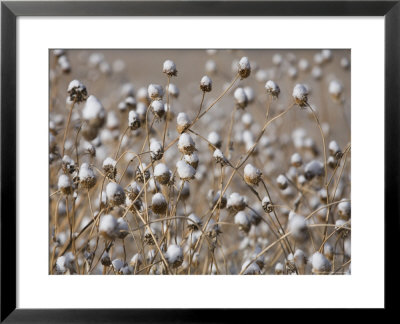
(18, 17, 384, 308)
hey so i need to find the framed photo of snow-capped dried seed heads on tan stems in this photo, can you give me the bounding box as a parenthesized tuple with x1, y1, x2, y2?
(49, 49, 351, 275)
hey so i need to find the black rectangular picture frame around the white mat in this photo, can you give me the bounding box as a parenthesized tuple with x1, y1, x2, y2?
(0, 0, 400, 323)
